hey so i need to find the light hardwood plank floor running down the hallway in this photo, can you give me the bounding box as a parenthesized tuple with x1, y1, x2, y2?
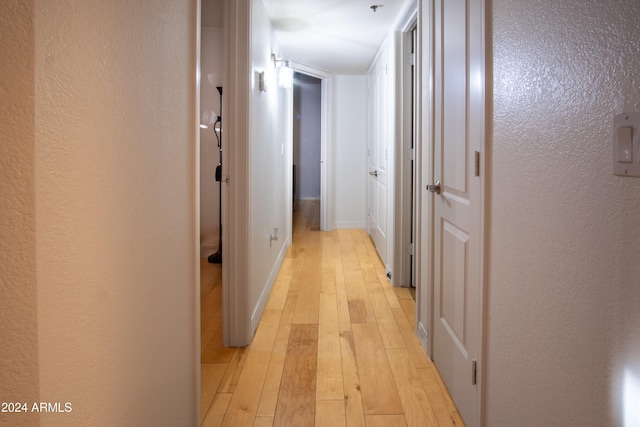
(201, 202, 464, 427)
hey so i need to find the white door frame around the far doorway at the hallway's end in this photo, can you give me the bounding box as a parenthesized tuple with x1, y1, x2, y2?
(289, 61, 335, 231)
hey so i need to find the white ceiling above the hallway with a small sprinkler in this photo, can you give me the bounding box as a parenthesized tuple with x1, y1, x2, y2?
(202, 0, 404, 74)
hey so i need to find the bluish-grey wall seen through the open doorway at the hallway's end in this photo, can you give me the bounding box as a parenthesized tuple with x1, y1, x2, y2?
(293, 74, 322, 199)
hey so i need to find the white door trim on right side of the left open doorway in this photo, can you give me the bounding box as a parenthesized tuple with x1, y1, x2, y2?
(222, 0, 251, 347)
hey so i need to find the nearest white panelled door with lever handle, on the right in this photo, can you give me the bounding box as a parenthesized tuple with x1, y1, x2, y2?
(429, 0, 485, 426)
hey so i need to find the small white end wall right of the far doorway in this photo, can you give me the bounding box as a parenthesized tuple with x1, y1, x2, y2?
(331, 76, 367, 228)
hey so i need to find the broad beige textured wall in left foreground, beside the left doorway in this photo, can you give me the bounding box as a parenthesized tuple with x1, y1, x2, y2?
(35, 0, 199, 426)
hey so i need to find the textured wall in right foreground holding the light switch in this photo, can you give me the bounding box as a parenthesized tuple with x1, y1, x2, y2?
(486, 0, 640, 426)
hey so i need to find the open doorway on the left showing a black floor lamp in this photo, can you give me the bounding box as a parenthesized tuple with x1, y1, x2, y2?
(198, 0, 234, 383)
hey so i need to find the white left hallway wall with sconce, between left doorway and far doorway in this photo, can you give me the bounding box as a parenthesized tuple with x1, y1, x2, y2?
(247, 0, 293, 331)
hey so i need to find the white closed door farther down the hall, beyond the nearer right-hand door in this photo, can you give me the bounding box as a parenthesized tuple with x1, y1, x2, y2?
(367, 49, 389, 265)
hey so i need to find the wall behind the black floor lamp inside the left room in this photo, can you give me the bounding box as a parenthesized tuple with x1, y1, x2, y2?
(200, 27, 225, 258)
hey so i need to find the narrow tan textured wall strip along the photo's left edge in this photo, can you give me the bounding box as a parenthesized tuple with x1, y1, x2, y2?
(0, 0, 39, 427)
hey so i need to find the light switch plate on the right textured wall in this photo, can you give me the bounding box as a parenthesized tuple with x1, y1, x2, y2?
(611, 112, 640, 177)
